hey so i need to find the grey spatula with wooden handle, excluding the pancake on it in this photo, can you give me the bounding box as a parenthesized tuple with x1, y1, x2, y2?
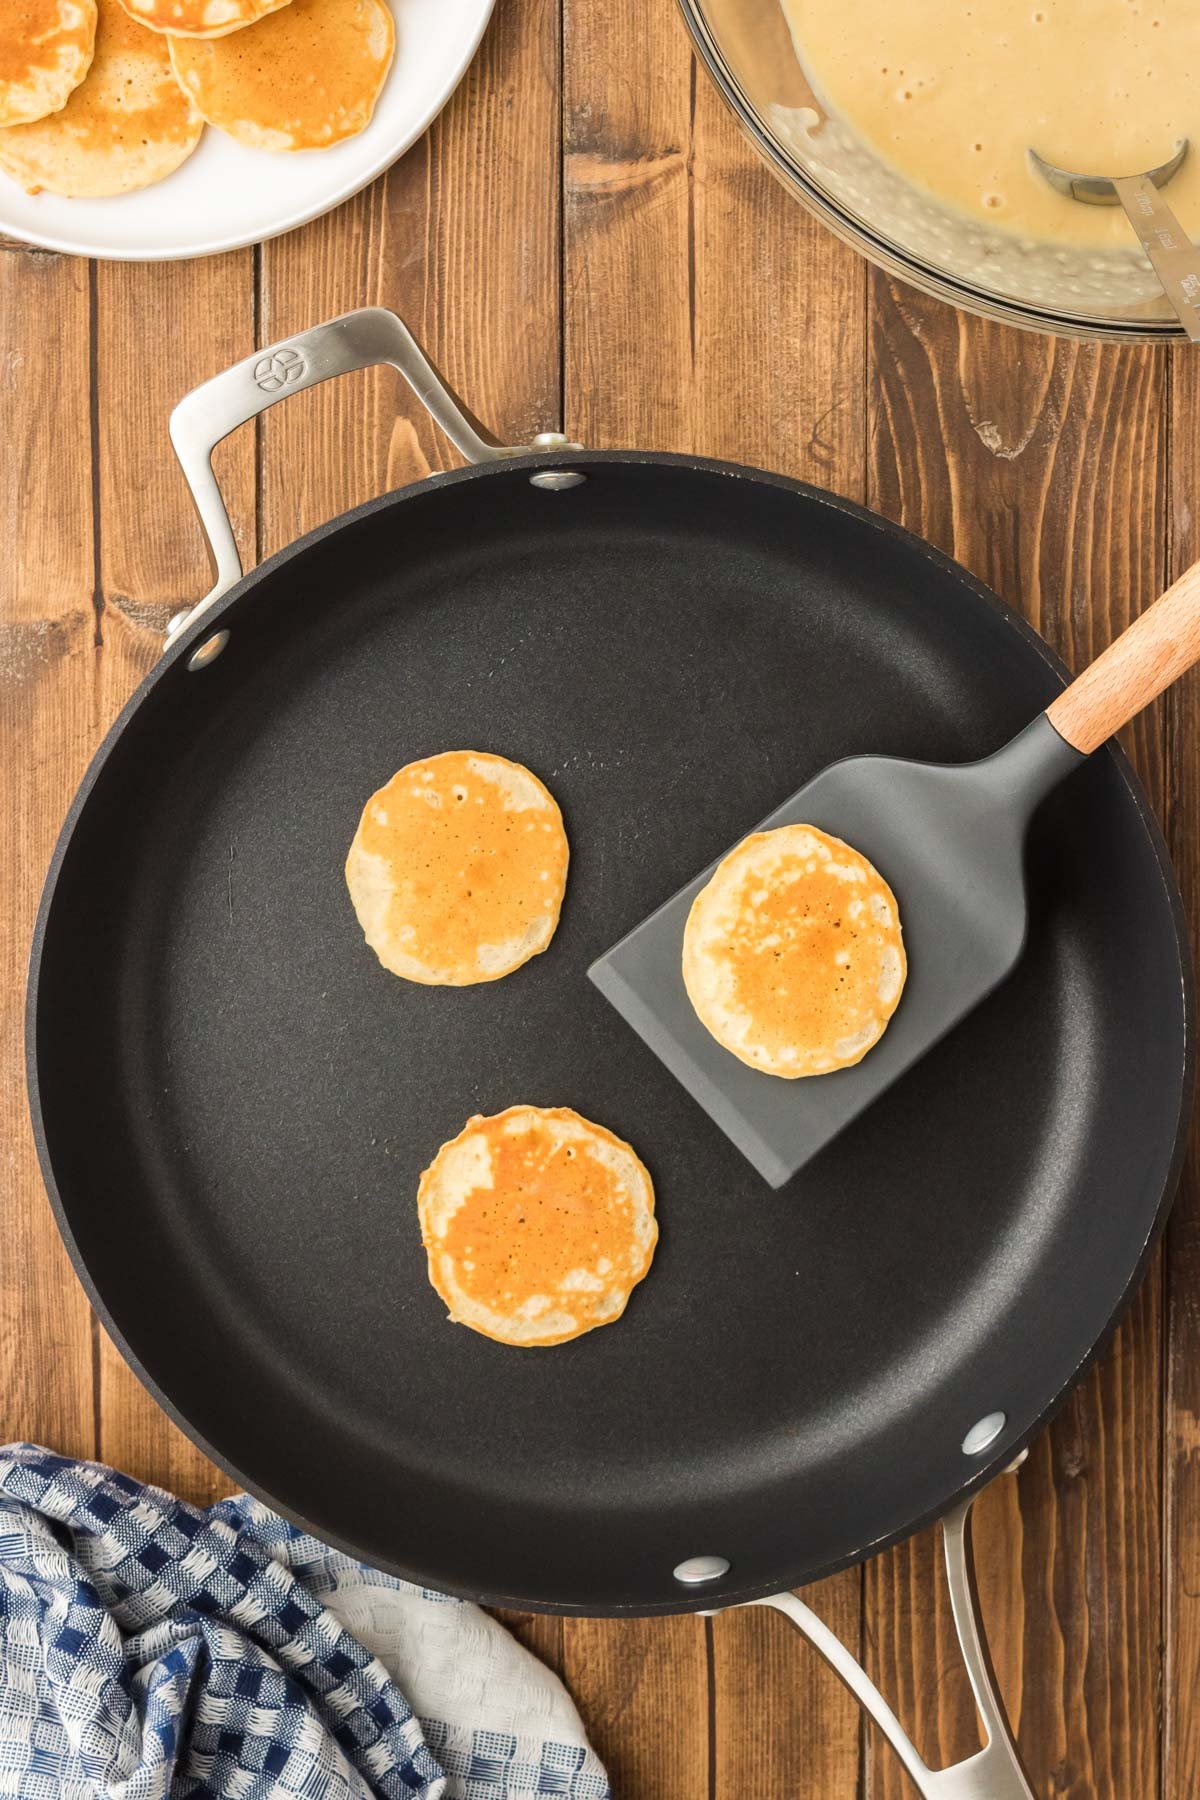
(588, 563, 1200, 1188)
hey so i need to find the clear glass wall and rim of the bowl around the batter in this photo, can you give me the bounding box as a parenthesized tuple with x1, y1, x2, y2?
(680, 0, 1186, 342)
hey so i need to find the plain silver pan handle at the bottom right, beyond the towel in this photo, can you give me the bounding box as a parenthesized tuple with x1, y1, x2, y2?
(750, 1476, 1034, 1800)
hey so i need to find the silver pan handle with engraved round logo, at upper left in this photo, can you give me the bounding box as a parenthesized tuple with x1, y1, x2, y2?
(167, 306, 581, 639)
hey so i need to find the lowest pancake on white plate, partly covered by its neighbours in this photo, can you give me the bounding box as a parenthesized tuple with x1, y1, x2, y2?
(0, 0, 203, 198)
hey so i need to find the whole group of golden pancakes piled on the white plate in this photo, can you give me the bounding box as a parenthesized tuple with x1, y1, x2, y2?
(0, 0, 396, 198)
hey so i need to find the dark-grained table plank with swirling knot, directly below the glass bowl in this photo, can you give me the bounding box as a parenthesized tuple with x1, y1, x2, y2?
(865, 275, 1166, 1800)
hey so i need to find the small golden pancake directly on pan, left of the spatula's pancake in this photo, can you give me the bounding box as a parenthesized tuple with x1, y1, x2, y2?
(345, 752, 569, 988)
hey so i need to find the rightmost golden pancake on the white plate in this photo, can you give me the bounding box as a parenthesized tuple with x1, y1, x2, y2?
(171, 0, 396, 149)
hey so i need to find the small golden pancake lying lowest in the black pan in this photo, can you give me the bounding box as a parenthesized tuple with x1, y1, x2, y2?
(417, 1107, 658, 1346)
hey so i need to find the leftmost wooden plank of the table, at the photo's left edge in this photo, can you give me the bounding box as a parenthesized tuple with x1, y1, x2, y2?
(0, 250, 95, 1456)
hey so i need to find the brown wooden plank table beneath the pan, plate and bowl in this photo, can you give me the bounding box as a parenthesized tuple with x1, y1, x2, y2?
(0, 0, 1200, 1800)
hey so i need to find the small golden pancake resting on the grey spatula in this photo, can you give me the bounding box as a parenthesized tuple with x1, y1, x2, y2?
(684, 824, 907, 1078)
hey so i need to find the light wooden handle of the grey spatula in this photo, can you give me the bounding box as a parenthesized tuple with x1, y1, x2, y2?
(1045, 563, 1200, 756)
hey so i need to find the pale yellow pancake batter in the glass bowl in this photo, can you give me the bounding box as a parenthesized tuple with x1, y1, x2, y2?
(783, 0, 1200, 248)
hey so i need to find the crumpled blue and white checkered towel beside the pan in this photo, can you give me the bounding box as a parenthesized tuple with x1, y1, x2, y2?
(0, 1444, 610, 1800)
